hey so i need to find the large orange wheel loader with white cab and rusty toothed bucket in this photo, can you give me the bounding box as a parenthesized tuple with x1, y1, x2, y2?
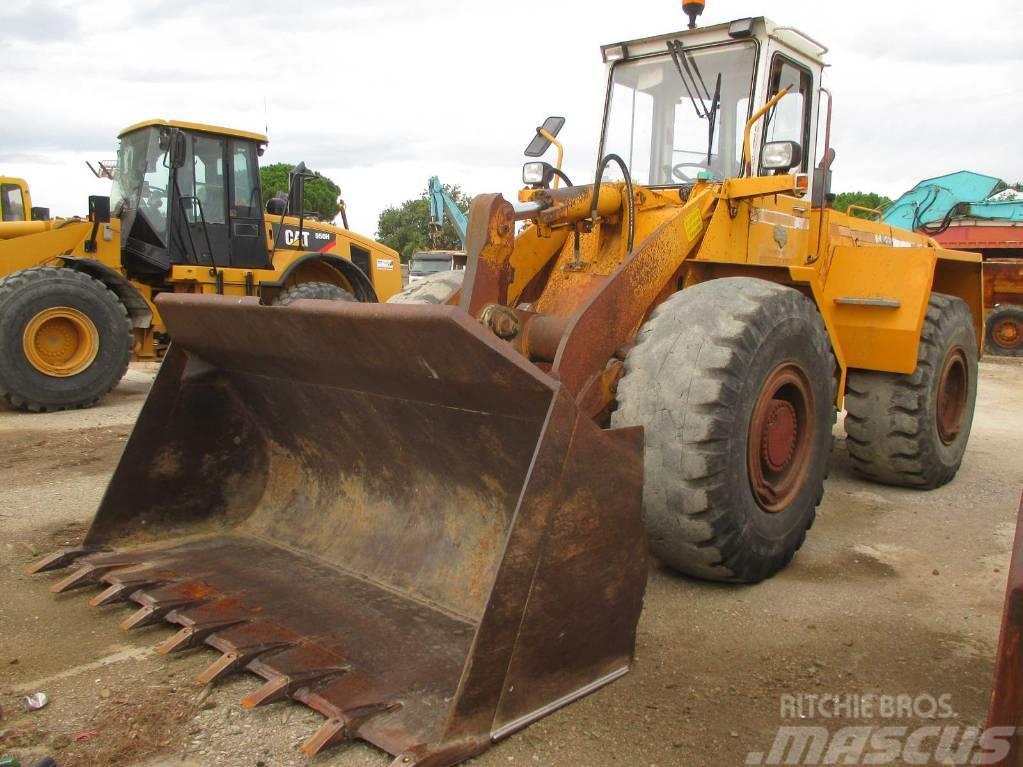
(32, 10, 982, 767)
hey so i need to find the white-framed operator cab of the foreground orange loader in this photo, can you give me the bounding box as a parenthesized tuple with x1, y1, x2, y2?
(601, 17, 827, 195)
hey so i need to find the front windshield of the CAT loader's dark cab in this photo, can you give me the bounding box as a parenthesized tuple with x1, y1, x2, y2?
(110, 128, 170, 234)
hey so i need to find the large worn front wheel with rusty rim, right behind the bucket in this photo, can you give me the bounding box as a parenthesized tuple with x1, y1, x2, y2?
(611, 277, 835, 583)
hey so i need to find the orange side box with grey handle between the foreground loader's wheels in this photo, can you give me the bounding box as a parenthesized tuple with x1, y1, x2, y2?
(820, 245, 937, 373)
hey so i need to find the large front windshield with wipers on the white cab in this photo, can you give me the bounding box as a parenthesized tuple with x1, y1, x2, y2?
(602, 41, 757, 186)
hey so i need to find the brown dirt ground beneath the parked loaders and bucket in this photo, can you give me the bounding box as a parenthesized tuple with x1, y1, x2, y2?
(0, 360, 1023, 767)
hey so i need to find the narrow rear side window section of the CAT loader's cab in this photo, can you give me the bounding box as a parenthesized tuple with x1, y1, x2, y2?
(227, 138, 270, 269)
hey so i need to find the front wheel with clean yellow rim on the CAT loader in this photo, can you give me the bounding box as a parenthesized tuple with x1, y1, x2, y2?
(0, 267, 133, 412)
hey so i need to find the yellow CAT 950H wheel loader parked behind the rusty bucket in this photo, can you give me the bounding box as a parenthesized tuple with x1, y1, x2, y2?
(0, 120, 401, 411)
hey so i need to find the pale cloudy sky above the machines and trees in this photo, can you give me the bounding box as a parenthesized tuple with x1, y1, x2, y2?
(0, 0, 1023, 234)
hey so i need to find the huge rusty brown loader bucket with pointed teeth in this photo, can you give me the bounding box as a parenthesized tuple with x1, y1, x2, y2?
(34, 296, 647, 767)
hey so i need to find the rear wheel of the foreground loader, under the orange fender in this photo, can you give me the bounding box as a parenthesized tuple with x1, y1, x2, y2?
(845, 292, 977, 490)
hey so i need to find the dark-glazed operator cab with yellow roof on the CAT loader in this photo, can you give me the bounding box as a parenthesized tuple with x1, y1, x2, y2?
(112, 121, 270, 275)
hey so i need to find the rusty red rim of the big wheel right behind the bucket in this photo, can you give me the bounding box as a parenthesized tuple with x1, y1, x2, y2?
(747, 362, 816, 513)
